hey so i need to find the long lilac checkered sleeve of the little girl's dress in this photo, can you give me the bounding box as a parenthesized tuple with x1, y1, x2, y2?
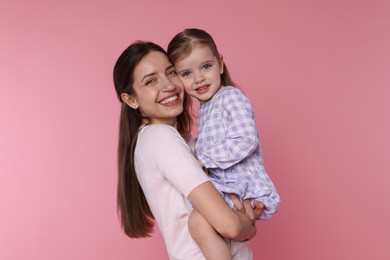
(196, 90, 259, 169)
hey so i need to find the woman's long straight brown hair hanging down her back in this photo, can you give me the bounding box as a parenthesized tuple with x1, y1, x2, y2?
(113, 41, 192, 238)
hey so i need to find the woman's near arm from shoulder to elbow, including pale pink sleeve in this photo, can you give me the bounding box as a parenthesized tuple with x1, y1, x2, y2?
(137, 125, 256, 240)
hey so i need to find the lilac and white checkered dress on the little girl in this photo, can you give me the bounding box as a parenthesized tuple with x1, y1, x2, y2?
(195, 86, 280, 219)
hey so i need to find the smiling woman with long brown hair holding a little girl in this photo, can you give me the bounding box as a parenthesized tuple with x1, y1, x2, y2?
(114, 42, 263, 259)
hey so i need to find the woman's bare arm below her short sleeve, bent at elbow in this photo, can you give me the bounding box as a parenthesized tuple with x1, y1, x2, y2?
(188, 182, 256, 241)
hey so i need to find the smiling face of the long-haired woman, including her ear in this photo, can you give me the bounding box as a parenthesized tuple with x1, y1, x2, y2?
(122, 51, 184, 126)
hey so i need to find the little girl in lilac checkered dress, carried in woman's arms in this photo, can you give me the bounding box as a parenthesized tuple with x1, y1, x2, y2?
(168, 29, 280, 259)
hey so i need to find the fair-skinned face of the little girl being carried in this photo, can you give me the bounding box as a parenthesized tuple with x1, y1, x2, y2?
(175, 45, 223, 104)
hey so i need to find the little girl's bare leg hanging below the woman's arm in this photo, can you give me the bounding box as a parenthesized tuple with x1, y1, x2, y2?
(188, 208, 232, 260)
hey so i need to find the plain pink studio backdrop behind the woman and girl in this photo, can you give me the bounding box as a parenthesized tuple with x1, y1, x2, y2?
(0, 0, 390, 260)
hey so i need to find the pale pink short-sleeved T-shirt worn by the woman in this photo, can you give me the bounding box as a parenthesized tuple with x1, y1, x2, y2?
(134, 124, 252, 260)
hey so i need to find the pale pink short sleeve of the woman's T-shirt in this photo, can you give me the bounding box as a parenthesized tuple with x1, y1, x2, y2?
(140, 125, 209, 197)
